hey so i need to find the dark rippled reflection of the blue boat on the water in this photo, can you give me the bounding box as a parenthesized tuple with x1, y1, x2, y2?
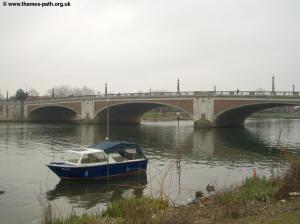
(46, 173, 147, 209)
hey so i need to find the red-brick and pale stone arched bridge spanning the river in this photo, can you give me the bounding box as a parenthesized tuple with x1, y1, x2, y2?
(23, 91, 300, 127)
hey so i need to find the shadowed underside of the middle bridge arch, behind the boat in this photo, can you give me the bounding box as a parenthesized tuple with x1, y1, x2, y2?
(94, 101, 192, 124)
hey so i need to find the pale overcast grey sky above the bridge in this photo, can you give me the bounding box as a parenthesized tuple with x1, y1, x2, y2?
(0, 0, 300, 94)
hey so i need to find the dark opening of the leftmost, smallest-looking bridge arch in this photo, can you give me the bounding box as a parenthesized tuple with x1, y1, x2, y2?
(28, 105, 78, 122)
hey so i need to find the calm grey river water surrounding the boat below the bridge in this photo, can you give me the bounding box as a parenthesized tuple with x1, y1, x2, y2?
(0, 119, 300, 224)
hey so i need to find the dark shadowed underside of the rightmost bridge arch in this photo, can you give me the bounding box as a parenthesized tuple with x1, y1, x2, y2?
(212, 102, 300, 127)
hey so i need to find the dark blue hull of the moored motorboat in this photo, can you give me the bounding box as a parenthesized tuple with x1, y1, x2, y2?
(47, 159, 148, 180)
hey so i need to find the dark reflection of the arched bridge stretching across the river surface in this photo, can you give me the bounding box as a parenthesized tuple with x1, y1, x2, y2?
(4, 120, 286, 159)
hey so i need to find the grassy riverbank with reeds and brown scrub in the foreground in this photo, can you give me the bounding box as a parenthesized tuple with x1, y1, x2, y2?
(43, 160, 300, 224)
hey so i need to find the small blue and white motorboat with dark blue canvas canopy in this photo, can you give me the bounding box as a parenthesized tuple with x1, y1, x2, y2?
(47, 141, 148, 180)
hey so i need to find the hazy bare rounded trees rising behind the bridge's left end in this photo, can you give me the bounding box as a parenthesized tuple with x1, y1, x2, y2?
(47, 85, 95, 97)
